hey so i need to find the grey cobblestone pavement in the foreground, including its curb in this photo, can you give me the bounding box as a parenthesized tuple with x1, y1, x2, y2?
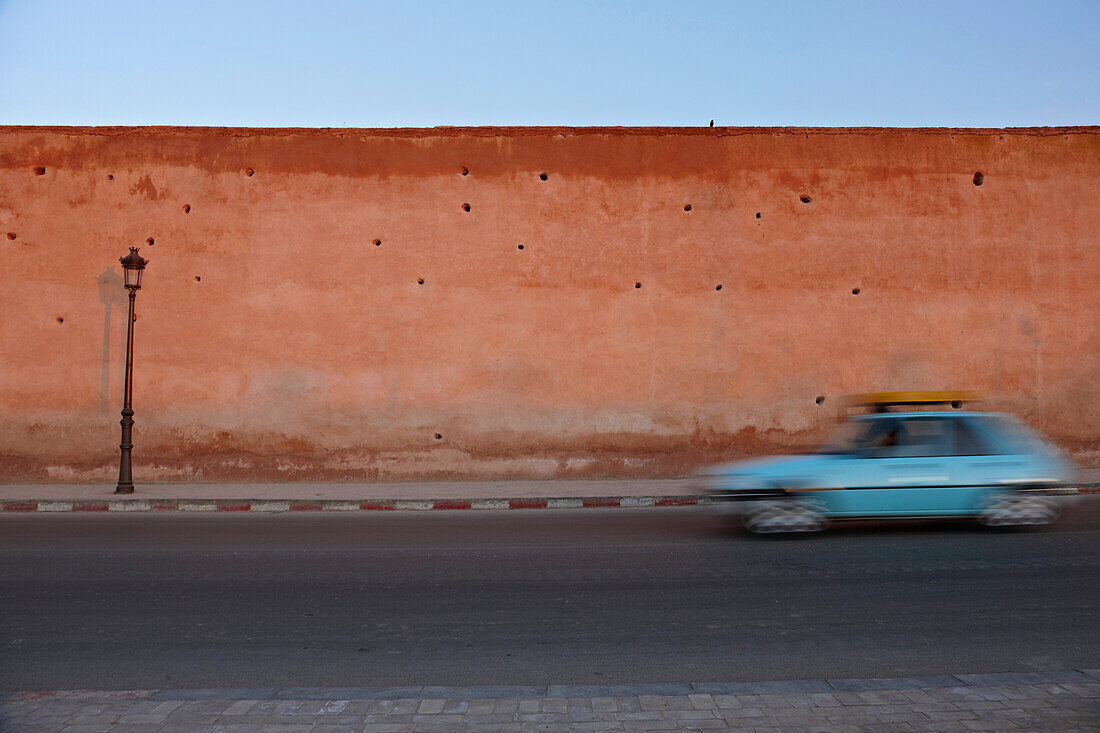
(0, 669, 1100, 733)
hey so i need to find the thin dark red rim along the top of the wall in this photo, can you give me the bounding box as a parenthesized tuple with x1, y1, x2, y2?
(0, 124, 1100, 138)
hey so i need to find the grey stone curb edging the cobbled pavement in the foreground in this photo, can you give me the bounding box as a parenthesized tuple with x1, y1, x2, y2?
(0, 669, 1100, 702)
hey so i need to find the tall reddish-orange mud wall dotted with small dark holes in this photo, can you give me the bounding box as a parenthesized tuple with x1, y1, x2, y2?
(0, 128, 1100, 481)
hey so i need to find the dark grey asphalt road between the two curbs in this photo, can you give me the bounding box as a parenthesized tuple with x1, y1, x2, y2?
(0, 501, 1100, 690)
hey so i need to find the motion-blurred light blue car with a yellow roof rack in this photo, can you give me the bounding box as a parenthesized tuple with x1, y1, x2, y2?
(702, 392, 1076, 533)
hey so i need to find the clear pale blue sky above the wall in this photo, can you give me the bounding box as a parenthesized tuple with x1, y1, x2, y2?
(0, 0, 1100, 127)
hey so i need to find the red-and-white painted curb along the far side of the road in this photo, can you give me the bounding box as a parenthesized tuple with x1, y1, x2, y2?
(0, 495, 711, 514)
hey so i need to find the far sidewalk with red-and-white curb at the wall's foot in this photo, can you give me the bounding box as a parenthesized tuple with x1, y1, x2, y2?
(0, 469, 1100, 512)
